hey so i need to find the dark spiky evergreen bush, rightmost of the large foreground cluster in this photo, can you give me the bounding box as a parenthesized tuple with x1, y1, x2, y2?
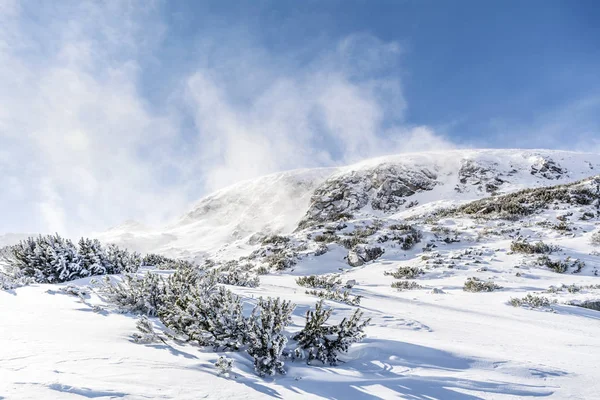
(293, 300, 370, 365)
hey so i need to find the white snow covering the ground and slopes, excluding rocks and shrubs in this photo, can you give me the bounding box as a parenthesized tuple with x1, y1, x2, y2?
(0, 150, 600, 400)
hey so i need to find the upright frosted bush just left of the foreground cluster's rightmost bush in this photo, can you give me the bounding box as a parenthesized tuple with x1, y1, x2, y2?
(247, 297, 295, 376)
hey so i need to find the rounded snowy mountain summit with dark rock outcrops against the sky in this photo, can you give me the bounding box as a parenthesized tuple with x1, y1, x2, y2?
(96, 149, 600, 258)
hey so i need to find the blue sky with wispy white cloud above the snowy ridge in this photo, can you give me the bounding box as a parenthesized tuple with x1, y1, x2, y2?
(0, 0, 600, 234)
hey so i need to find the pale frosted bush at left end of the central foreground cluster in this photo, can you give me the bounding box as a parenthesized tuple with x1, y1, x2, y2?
(100, 272, 165, 317)
